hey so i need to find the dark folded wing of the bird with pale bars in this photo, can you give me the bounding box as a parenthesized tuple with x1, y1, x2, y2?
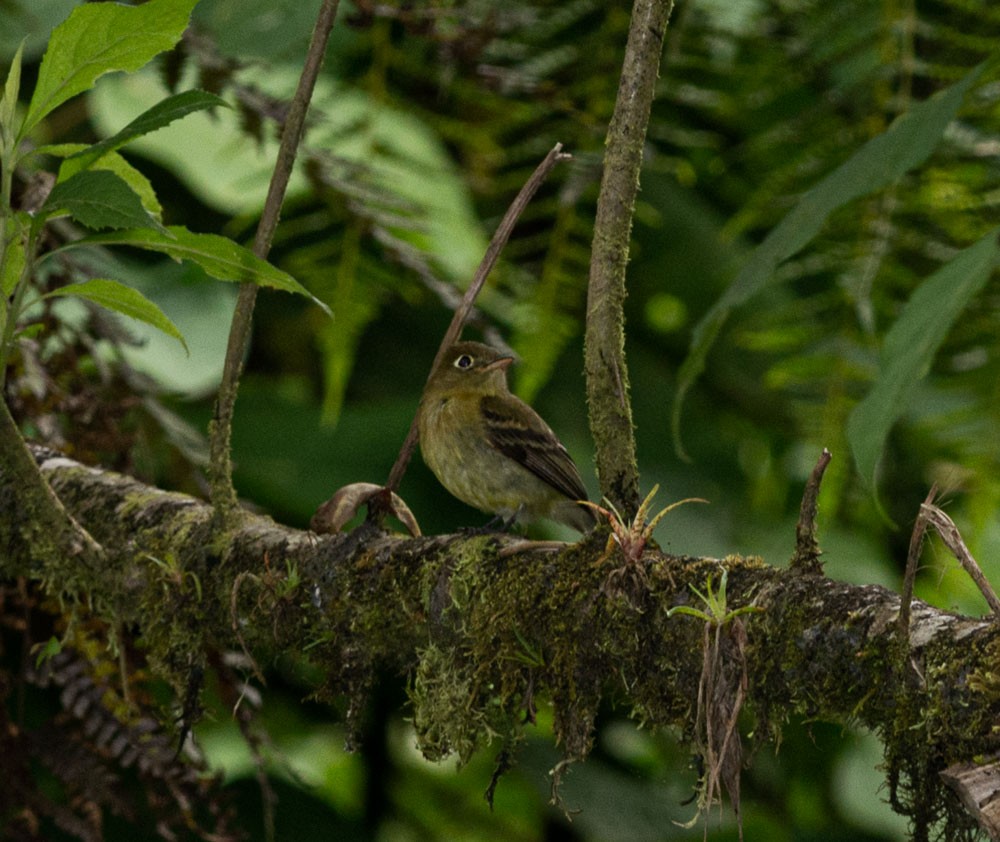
(479, 395, 587, 500)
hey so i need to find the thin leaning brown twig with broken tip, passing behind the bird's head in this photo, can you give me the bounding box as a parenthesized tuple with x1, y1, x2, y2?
(385, 143, 573, 491)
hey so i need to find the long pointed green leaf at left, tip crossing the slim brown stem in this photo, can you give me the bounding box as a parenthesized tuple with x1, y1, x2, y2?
(62, 225, 330, 314)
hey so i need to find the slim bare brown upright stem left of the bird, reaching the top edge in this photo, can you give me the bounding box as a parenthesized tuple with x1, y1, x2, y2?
(209, 0, 339, 520)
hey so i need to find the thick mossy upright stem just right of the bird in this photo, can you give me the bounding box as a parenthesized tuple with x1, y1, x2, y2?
(585, 0, 673, 515)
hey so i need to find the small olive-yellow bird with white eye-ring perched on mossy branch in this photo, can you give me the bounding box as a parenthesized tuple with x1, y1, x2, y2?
(417, 341, 596, 533)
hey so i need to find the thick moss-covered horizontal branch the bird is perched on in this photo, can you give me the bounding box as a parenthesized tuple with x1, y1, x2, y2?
(9, 452, 1000, 822)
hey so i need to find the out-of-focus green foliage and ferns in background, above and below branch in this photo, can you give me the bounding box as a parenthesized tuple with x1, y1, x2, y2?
(0, 0, 1000, 842)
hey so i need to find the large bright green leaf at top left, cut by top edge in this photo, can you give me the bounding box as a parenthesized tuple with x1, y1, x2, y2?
(21, 0, 198, 134)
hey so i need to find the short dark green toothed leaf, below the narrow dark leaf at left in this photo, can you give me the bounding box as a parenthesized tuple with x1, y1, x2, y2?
(39, 170, 166, 233)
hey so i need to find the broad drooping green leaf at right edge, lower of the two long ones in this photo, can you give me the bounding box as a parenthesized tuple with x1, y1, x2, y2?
(847, 228, 1000, 496)
